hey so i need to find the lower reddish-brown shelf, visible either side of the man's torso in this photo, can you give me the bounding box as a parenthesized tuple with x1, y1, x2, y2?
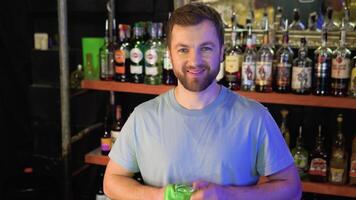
(85, 148, 356, 197)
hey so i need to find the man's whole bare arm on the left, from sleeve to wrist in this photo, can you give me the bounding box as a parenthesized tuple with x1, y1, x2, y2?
(104, 160, 164, 200)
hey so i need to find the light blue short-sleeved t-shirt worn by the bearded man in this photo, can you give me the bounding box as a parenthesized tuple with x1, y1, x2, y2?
(109, 87, 293, 187)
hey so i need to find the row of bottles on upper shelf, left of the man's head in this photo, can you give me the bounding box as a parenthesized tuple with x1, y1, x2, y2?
(100, 20, 176, 85)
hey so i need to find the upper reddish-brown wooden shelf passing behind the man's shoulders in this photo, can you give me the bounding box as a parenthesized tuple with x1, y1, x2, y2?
(82, 80, 356, 109)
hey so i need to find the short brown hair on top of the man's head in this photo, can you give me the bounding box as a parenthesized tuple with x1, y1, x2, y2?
(167, 3, 224, 48)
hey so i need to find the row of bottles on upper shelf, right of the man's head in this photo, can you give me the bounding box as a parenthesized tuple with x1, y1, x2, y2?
(220, 12, 356, 96)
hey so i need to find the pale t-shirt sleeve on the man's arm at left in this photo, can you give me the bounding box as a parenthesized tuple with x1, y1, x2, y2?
(109, 111, 139, 173)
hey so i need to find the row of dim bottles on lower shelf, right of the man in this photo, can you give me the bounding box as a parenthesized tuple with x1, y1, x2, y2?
(280, 110, 356, 185)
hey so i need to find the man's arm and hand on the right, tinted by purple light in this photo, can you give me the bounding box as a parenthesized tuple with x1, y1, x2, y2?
(191, 164, 302, 200)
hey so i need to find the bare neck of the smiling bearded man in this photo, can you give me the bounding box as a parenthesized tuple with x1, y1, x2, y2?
(174, 82, 221, 110)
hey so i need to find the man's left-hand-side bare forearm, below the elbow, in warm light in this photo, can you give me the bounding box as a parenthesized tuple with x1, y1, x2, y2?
(104, 174, 164, 200)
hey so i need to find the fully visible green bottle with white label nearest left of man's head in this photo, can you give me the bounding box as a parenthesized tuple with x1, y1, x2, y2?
(144, 23, 163, 85)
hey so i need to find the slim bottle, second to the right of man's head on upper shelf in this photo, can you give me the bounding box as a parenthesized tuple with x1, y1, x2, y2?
(241, 27, 257, 91)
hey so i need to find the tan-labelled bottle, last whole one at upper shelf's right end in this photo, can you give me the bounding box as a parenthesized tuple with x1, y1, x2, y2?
(331, 23, 351, 96)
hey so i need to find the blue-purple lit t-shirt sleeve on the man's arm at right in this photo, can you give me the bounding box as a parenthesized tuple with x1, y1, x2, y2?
(257, 110, 294, 176)
